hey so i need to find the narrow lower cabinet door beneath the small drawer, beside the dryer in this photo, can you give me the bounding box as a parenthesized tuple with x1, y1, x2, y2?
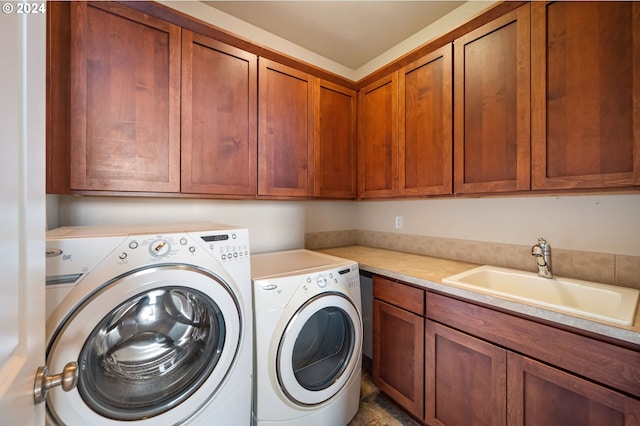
(373, 299, 424, 418)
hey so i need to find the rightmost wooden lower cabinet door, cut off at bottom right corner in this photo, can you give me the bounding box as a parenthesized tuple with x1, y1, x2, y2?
(508, 353, 640, 426)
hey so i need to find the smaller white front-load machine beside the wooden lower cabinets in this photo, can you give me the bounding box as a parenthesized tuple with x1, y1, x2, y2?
(251, 250, 362, 426)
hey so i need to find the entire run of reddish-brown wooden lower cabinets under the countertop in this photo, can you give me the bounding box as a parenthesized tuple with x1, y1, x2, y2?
(373, 275, 640, 426)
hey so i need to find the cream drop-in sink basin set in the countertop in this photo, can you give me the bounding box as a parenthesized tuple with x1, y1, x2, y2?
(442, 265, 640, 325)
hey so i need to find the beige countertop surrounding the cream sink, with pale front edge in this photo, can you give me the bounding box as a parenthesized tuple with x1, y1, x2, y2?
(318, 246, 640, 344)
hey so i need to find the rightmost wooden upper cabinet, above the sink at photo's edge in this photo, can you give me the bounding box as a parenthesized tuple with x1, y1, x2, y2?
(531, 2, 640, 189)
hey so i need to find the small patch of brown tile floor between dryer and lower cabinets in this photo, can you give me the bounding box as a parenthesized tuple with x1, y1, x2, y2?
(347, 357, 420, 426)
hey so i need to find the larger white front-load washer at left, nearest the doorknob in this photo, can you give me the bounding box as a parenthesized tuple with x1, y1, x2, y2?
(46, 223, 253, 426)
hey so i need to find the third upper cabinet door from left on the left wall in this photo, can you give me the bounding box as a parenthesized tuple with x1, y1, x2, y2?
(258, 58, 313, 196)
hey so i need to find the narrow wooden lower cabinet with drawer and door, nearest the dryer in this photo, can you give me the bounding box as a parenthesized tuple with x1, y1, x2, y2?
(373, 276, 424, 419)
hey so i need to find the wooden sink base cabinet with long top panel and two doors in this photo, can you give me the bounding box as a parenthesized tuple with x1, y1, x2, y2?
(425, 292, 640, 426)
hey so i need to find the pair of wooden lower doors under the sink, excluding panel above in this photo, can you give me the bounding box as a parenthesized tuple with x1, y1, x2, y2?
(425, 320, 640, 426)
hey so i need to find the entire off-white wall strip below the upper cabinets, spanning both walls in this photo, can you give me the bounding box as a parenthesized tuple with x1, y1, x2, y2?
(47, 194, 640, 256)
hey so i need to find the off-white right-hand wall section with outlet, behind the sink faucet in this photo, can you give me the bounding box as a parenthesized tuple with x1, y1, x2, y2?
(357, 194, 640, 256)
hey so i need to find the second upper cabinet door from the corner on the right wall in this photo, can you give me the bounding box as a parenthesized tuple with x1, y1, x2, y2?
(398, 44, 453, 195)
